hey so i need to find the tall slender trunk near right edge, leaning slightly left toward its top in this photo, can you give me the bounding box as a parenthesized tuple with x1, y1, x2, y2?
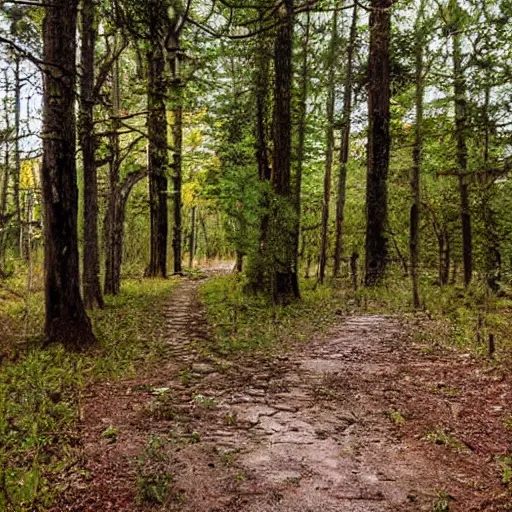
(451, 0, 473, 286)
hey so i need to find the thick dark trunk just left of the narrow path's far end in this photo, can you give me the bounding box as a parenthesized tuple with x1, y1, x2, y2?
(146, 40, 169, 277)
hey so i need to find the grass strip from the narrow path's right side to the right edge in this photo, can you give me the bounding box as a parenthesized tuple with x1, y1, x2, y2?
(202, 272, 512, 360)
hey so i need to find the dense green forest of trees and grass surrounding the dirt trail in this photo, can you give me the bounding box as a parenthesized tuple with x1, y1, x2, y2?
(0, 0, 512, 511)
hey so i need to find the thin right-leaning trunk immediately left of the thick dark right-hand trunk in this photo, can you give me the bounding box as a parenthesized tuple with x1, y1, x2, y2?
(333, 2, 358, 277)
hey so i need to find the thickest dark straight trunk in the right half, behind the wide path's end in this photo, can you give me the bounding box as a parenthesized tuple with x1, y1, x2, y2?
(365, 0, 392, 286)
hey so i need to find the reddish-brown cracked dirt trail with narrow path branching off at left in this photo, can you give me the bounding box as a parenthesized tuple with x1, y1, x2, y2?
(55, 279, 512, 512)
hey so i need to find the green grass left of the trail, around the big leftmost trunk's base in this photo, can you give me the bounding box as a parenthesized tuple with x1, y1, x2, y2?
(0, 280, 180, 512)
